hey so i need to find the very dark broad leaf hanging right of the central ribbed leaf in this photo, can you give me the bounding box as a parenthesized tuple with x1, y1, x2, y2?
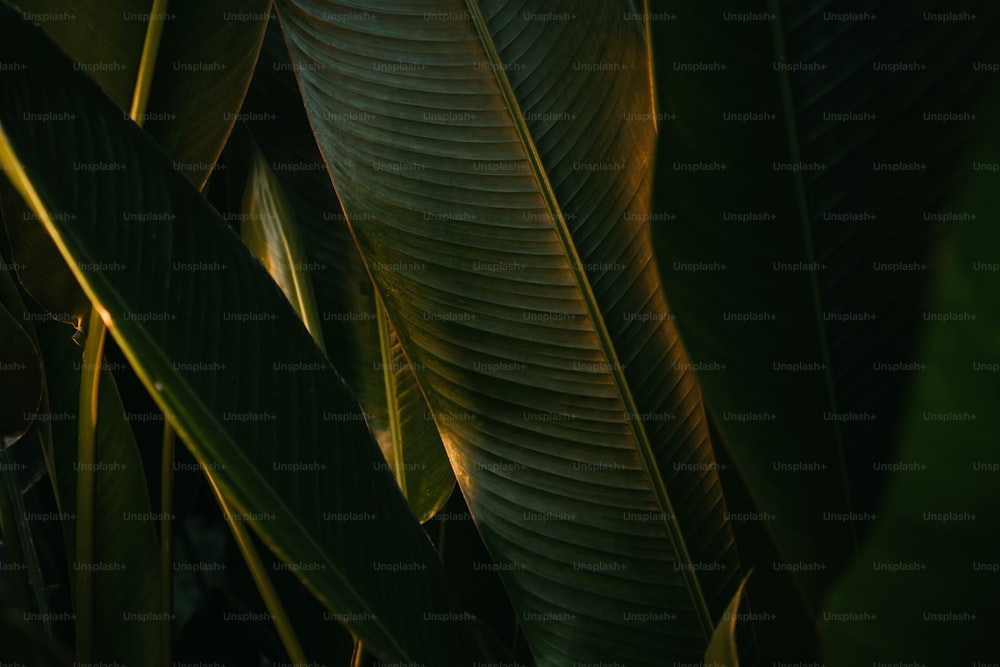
(650, 0, 1000, 612)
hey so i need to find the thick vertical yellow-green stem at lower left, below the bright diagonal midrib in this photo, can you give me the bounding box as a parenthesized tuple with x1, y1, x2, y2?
(76, 307, 106, 663)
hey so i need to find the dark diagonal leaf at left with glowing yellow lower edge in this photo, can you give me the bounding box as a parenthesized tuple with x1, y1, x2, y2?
(0, 9, 504, 665)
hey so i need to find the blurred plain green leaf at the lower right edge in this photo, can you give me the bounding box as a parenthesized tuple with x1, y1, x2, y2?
(821, 90, 1000, 667)
